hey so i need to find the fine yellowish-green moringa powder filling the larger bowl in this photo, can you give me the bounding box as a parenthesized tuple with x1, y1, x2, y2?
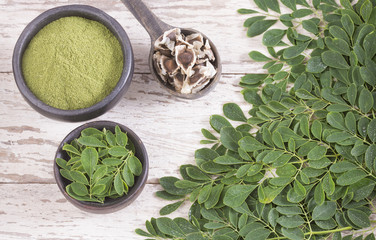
(22, 17, 123, 110)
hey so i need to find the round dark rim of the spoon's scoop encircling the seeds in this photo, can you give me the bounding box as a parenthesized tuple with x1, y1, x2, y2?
(149, 27, 222, 99)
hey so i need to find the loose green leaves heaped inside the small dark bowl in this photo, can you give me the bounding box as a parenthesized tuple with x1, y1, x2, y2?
(56, 126, 142, 203)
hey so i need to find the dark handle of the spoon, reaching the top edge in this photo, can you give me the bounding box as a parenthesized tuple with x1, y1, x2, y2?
(122, 0, 173, 42)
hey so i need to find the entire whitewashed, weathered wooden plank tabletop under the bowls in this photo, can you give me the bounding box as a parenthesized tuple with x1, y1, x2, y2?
(0, 0, 261, 240)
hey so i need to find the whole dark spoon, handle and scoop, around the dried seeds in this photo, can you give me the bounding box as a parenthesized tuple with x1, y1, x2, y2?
(122, 0, 222, 99)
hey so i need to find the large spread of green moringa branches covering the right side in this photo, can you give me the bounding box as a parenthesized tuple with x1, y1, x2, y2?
(136, 0, 376, 240)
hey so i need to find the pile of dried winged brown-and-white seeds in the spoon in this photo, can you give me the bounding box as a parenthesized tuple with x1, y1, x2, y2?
(153, 28, 217, 94)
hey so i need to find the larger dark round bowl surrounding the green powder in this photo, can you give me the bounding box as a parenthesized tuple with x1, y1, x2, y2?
(12, 5, 134, 122)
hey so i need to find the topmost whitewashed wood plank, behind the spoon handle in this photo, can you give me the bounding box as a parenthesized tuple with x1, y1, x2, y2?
(0, 0, 261, 73)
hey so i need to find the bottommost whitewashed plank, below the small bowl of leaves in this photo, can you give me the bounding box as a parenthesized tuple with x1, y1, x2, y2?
(0, 184, 189, 240)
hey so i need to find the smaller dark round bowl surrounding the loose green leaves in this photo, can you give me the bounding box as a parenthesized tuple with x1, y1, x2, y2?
(54, 121, 149, 213)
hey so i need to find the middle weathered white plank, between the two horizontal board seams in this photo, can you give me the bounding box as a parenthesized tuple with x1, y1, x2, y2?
(0, 73, 248, 183)
